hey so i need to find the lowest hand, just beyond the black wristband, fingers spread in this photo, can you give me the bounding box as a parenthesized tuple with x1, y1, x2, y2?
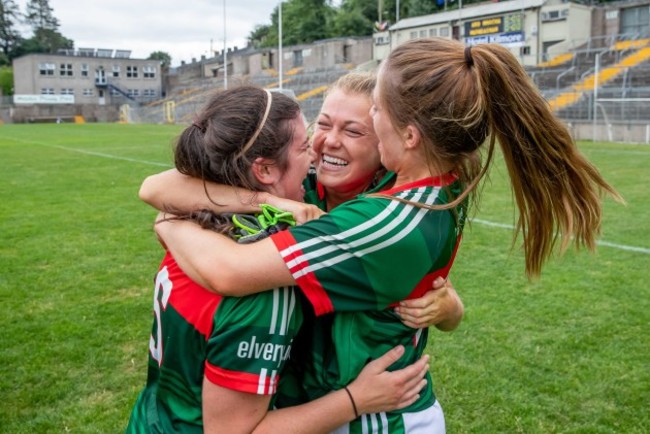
(348, 345, 429, 414)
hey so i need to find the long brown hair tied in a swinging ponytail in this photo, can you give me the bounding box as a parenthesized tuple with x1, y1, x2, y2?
(378, 38, 622, 277)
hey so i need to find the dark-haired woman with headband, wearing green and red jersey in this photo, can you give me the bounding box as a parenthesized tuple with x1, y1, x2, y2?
(127, 86, 426, 433)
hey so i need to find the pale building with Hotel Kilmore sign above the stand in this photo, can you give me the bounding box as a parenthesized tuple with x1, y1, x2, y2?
(373, 0, 650, 66)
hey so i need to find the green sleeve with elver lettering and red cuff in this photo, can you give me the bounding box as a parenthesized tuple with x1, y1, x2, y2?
(205, 287, 302, 395)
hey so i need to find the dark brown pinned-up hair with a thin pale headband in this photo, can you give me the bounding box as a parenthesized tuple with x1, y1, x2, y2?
(170, 86, 301, 232)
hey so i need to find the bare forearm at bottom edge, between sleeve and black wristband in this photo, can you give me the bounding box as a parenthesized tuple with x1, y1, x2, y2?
(253, 390, 355, 434)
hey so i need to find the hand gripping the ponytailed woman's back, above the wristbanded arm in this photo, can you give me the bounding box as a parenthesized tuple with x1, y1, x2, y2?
(395, 277, 464, 331)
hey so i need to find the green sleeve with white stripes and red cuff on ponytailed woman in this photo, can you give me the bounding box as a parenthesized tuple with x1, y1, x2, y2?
(272, 198, 457, 315)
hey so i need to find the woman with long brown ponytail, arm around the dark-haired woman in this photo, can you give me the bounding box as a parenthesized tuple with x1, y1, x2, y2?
(156, 39, 618, 434)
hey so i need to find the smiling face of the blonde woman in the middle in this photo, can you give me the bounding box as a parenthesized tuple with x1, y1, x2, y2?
(313, 89, 381, 199)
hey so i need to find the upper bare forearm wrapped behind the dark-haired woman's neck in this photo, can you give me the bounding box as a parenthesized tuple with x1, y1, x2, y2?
(139, 169, 267, 213)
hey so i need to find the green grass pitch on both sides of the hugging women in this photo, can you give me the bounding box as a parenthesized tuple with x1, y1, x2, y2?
(0, 124, 650, 434)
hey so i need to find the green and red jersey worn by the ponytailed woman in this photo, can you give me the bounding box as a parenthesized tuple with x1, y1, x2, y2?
(272, 175, 465, 413)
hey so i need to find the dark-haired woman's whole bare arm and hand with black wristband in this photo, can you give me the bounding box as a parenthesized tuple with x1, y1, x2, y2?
(203, 346, 429, 434)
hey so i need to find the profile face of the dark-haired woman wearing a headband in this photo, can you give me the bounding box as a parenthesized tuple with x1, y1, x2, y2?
(269, 115, 313, 202)
